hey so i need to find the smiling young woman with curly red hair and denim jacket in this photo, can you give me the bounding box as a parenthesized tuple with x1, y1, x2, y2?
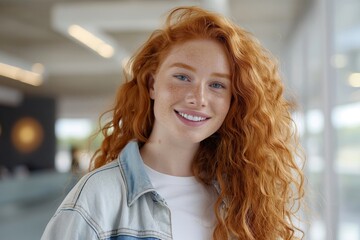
(42, 7, 303, 240)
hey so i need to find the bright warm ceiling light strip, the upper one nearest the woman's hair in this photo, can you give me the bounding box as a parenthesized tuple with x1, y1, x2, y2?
(68, 25, 114, 58)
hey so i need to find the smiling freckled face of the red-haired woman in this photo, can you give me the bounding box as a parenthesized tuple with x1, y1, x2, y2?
(150, 39, 231, 143)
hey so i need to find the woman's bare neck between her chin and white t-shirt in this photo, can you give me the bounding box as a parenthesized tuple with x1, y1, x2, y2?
(140, 137, 199, 177)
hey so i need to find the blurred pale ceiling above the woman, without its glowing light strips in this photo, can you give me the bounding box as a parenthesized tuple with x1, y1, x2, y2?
(0, 0, 306, 117)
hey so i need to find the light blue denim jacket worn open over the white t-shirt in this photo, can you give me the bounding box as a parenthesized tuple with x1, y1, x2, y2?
(41, 142, 172, 240)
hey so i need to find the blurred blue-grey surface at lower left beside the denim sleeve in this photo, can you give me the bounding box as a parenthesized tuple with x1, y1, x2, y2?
(0, 172, 78, 240)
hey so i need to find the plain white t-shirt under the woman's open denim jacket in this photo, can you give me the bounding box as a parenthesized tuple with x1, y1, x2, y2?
(144, 164, 216, 240)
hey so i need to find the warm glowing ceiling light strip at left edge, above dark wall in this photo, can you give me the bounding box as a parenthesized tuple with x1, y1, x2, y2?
(0, 63, 43, 86)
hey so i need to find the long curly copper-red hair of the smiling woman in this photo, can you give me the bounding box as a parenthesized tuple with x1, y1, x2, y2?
(91, 7, 304, 240)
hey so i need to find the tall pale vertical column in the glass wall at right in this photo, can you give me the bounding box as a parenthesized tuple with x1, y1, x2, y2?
(319, 0, 339, 240)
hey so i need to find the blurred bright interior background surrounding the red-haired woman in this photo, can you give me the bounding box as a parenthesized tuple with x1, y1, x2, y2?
(0, 0, 360, 240)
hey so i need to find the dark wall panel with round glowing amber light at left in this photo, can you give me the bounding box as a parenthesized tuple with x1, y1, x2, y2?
(0, 96, 56, 171)
